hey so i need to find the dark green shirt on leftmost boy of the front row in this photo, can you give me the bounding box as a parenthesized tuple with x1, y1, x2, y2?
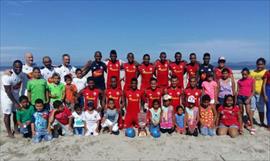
(16, 105, 35, 124)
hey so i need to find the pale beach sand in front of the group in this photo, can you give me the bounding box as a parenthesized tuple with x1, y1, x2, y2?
(0, 70, 270, 161)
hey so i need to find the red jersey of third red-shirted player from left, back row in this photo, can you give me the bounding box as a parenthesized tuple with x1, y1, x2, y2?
(139, 64, 155, 90)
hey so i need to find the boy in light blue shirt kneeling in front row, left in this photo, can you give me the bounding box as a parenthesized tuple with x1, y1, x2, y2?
(31, 99, 52, 143)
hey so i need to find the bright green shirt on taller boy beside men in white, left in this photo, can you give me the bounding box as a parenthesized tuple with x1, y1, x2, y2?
(27, 79, 48, 105)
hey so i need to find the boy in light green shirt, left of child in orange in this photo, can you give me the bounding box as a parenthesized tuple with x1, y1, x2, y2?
(48, 73, 65, 109)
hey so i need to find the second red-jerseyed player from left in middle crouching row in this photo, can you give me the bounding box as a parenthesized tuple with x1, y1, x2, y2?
(102, 76, 124, 129)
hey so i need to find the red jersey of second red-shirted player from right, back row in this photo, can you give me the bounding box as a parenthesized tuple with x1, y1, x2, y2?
(170, 61, 186, 88)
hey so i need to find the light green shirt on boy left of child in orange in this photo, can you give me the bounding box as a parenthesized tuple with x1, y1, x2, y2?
(48, 83, 65, 102)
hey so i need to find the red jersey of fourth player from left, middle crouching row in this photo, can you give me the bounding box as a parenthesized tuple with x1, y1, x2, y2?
(145, 88, 163, 108)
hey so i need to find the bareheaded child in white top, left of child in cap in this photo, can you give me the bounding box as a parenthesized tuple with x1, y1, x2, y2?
(70, 104, 86, 136)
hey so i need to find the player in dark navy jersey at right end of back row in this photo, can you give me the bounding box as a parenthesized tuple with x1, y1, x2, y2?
(197, 53, 214, 88)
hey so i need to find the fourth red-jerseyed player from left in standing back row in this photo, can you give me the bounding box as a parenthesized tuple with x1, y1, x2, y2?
(155, 52, 169, 89)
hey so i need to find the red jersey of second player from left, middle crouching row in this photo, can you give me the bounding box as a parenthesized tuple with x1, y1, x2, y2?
(105, 88, 122, 109)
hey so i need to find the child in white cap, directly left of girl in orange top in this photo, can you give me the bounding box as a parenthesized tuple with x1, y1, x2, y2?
(185, 95, 199, 136)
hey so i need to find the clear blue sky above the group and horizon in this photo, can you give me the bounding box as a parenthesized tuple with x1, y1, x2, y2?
(0, 0, 270, 66)
